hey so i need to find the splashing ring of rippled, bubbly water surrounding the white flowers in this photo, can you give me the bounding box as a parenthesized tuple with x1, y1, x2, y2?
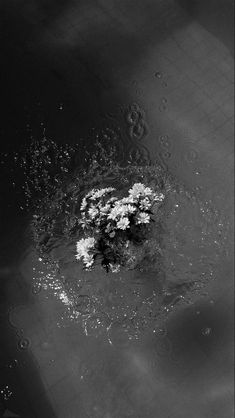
(8, 126, 227, 342)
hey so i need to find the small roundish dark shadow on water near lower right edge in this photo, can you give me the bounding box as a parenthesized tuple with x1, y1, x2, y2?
(167, 301, 233, 370)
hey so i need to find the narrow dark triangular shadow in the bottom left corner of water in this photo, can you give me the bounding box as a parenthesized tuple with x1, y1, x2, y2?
(0, 316, 56, 418)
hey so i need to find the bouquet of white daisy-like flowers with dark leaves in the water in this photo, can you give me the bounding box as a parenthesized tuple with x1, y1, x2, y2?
(76, 183, 164, 272)
